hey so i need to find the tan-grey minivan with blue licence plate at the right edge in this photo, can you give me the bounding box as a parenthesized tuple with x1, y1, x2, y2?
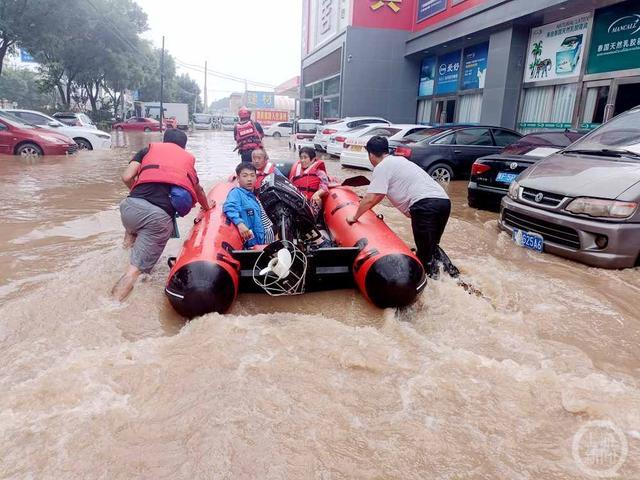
(498, 107, 640, 268)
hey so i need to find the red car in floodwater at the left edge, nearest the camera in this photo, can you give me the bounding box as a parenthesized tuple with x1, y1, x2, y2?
(0, 112, 78, 157)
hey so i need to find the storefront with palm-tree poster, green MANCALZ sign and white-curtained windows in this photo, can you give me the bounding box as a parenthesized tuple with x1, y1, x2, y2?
(518, 1, 640, 133)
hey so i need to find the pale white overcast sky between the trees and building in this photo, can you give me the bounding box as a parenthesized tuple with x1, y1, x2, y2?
(135, 0, 302, 102)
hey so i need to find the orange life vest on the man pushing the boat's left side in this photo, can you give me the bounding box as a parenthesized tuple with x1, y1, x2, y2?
(132, 143, 198, 205)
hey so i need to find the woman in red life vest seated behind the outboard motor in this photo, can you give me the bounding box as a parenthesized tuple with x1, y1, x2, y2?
(289, 147, 329, 209)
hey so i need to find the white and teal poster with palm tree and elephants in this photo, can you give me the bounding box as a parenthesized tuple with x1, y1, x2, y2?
(524, 13, 591, 82)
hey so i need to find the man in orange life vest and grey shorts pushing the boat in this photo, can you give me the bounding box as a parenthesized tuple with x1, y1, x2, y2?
(111, 129, 215, 300)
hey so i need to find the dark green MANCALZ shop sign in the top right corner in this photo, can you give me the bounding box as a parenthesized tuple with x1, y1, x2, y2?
(587, 1, 640, 73)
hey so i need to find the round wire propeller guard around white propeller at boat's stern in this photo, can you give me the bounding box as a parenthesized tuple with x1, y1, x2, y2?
(253, 240, 307, 297)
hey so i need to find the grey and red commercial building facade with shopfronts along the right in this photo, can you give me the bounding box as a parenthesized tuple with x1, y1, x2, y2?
(301, 0, 640, 132)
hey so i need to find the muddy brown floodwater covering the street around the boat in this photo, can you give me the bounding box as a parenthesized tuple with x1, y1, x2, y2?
(0, 132, 640, 480)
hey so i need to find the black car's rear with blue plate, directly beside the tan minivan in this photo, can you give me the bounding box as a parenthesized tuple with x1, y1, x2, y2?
(467, 131, 584, 209)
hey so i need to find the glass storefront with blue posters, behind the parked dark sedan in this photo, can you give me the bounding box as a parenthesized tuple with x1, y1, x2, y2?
(416, 42, 489, 123)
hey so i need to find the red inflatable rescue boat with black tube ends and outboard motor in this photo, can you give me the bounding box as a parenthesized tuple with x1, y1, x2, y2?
(165, 175, 426, 318)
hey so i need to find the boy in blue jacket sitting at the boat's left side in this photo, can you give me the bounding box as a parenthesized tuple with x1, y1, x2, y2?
(222, 163, 274, 248)
